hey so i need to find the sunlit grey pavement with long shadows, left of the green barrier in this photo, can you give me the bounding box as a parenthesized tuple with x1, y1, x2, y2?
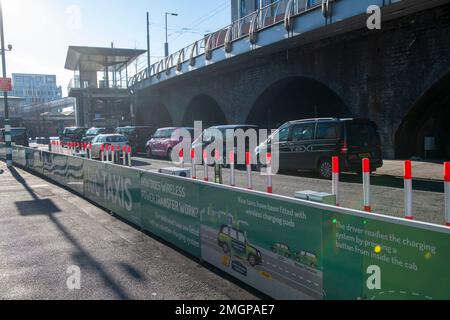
(0, 162, 257, 300)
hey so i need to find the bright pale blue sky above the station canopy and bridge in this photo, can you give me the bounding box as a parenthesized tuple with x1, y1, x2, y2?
(3, 0, 231, 96)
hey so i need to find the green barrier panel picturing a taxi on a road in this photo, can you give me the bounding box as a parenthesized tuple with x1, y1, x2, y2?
(200, 185, 323, 299)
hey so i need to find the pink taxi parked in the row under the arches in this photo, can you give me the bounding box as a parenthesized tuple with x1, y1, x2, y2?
(145, 127, 194, 159)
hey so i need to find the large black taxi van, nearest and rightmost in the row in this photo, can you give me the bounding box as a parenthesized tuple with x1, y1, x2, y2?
(256, 118, 383, 179)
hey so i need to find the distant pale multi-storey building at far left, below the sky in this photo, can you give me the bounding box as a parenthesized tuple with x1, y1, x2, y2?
(12, 73, 62, 105)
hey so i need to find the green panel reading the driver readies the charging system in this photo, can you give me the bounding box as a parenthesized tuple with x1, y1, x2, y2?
(323, 212, 450, 300)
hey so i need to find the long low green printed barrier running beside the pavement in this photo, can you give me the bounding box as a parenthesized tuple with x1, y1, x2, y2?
(0, 146, 450, 300)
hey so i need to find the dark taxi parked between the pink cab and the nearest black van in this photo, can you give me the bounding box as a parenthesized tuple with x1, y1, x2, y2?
(192, 124, 259, 164)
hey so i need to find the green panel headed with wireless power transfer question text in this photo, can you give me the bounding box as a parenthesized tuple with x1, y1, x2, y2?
(141, 173, 201, 258)
